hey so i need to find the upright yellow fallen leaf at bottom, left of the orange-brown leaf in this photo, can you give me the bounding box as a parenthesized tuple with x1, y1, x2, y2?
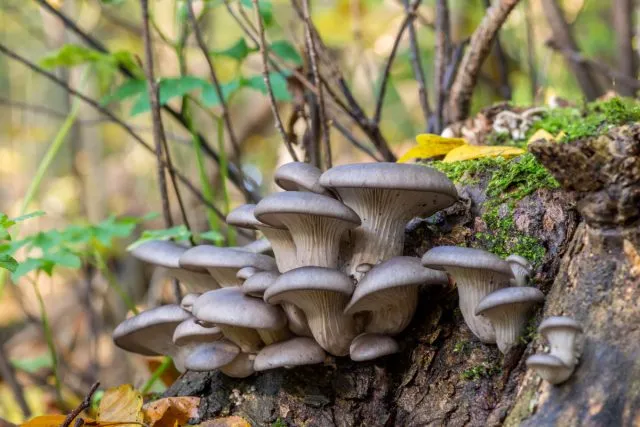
(97, 384, 144, 427)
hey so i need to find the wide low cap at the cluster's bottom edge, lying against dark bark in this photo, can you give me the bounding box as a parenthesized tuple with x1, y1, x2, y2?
(253, 337, 326, 371)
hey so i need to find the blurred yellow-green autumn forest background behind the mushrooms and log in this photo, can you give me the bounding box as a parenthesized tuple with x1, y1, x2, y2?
(0, 0, 638, 422)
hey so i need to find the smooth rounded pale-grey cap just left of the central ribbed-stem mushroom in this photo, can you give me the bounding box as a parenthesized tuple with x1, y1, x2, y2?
(192, 287, 287, 329)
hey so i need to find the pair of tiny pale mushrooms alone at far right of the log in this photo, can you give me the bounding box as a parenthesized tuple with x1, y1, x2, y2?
(526, 316, 582, 384)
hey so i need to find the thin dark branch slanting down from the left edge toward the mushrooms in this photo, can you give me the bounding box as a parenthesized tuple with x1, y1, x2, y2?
(0, 43, 225, 224)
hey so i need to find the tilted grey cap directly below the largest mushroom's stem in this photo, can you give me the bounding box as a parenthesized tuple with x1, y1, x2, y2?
(344, 256, 449, 314)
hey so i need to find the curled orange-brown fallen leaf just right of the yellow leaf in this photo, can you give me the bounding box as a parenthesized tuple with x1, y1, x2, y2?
(143, 397, 200, 427)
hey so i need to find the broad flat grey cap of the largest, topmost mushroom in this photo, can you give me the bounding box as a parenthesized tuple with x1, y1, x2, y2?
(320, 162, 458, 196)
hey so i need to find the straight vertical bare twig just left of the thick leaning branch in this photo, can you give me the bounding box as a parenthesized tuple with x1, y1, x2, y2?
(433, 0, 451, 134)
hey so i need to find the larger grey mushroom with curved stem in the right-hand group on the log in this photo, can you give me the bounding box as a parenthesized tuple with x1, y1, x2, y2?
(422, 246, 513, 344)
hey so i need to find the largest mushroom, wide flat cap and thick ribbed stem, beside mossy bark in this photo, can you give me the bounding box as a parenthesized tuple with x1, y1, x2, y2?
(320, 163, 458, 277)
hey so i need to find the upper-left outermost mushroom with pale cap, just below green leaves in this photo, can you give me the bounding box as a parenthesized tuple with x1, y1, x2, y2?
(131, 240, 220, 290)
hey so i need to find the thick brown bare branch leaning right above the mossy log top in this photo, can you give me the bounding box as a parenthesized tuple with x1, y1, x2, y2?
(448, 0, 519, 122)
